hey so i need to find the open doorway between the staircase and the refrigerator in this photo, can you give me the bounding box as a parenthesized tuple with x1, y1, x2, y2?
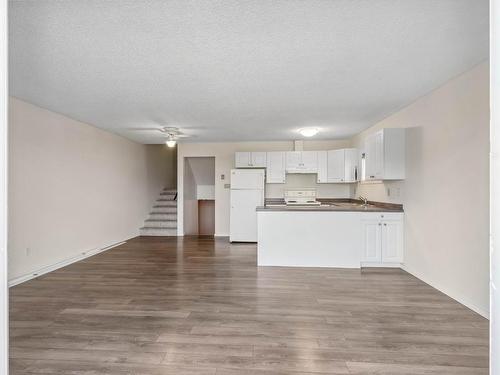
(183, 157, 215, 236)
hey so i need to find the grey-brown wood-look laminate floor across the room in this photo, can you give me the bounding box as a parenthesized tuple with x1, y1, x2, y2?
(10, 237, 488, 375)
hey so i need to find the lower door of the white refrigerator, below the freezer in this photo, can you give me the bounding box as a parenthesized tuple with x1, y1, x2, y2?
(229, 190, 264, 242)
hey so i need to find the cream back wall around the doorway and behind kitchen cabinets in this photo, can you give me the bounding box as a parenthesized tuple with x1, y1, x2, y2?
(177, 140, 350, 236)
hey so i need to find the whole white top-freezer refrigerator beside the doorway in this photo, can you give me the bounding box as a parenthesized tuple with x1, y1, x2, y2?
(229, 169, 265, 242)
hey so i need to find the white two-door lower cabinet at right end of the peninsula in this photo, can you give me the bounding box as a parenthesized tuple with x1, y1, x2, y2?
(361, 213, 404, 267)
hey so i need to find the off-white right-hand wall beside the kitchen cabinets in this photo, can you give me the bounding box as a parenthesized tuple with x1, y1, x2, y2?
(353, 63, 489, 316)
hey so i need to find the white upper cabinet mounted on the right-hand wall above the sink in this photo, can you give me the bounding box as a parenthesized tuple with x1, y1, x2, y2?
(362, 128, 406, 180)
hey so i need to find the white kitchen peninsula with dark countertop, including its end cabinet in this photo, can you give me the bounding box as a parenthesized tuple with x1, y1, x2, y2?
(257, 199, 404, 268)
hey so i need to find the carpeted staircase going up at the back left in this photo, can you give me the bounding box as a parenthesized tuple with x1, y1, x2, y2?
(140, 189, 177, 236)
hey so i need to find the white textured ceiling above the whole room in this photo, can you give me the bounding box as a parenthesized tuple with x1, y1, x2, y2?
(9, 0, 489, 143)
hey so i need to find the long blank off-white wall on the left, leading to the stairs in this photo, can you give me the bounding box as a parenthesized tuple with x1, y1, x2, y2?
(8, 98, 174, 279)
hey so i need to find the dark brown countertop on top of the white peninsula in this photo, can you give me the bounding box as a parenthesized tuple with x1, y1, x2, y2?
(257, 199, 404, 212)
